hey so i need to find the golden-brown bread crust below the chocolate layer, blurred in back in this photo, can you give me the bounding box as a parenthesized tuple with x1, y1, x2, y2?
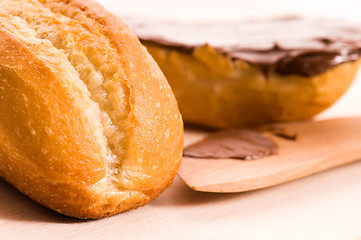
(145, 42, 361, 128)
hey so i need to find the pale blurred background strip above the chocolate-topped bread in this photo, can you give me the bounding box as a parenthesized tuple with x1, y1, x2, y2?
(101, 0, 361, 20)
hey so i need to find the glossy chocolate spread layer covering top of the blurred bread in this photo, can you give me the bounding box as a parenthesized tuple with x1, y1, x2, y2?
(125, 18, 361, 76)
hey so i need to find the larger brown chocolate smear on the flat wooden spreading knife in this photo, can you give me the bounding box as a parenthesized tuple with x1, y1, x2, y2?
(183, 129, 278, 160)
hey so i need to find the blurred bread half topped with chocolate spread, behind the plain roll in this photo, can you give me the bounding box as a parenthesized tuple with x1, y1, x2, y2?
(126, 18, 361, 128)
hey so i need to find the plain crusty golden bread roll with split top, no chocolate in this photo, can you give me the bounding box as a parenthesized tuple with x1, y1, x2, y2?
(0, 0, 183, 218)
